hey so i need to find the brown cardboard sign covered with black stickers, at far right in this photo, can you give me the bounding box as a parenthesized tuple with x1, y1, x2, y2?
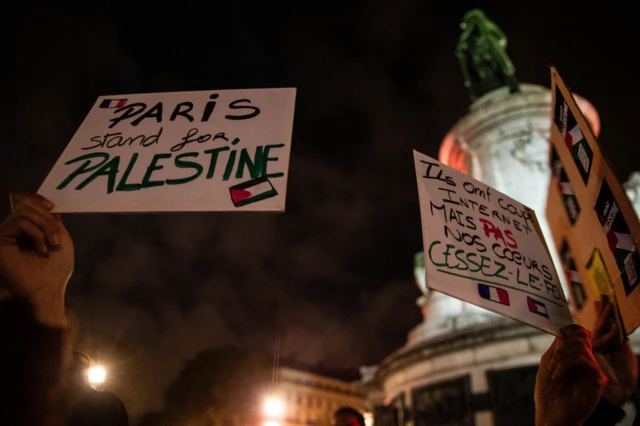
(546, 67, 640, 334)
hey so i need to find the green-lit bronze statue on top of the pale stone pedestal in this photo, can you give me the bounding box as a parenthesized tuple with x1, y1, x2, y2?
(456, 9, 518, 101)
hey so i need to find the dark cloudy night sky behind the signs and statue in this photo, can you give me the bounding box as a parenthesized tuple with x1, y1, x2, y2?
(0, 0, 640, 416)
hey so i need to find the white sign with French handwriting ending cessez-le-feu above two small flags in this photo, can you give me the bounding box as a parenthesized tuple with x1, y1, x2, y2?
(414, 151, 573, 335)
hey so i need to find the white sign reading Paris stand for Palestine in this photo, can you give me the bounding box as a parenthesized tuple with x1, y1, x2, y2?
(38, 88, 296, 213)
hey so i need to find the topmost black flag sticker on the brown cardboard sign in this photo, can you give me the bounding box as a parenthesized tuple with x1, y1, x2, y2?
(553, 86, 593, 185)
